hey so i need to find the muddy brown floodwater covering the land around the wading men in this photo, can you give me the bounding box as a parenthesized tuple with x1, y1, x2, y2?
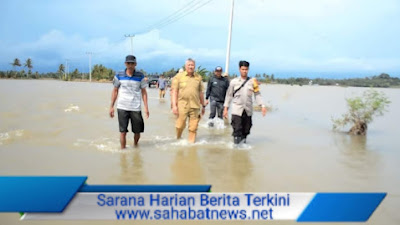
(0, 80, 400, 225)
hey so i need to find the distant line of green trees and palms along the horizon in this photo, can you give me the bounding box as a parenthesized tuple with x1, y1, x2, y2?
(0, 58, 400, 87)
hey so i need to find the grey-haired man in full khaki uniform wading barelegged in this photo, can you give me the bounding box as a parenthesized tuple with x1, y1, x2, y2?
(172, 58, 205, 143)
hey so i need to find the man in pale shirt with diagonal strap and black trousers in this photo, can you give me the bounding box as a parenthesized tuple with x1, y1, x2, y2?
(224, 61, 267, 144)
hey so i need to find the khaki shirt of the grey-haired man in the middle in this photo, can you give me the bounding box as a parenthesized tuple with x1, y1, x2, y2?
(172, 71, 204, 109)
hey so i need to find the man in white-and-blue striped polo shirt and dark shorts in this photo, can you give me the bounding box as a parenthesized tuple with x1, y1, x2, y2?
(110, 55, 149, 149)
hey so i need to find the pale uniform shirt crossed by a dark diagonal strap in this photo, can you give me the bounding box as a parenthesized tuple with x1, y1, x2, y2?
(224, 77, 264, 116)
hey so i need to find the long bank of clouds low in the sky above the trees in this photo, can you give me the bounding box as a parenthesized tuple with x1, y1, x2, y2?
(0, 27, 400, 72)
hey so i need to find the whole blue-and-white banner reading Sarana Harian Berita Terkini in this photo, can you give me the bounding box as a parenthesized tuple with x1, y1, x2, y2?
(0, 176, 386, 222)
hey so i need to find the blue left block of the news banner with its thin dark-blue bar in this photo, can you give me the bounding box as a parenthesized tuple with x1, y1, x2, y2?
(0, 176, 211, 212)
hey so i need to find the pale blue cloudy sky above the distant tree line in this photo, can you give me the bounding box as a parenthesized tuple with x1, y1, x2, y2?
(0, 0, 400, 78)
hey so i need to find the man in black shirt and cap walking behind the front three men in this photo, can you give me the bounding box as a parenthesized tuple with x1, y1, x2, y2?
(206, 66, 229, 127)
